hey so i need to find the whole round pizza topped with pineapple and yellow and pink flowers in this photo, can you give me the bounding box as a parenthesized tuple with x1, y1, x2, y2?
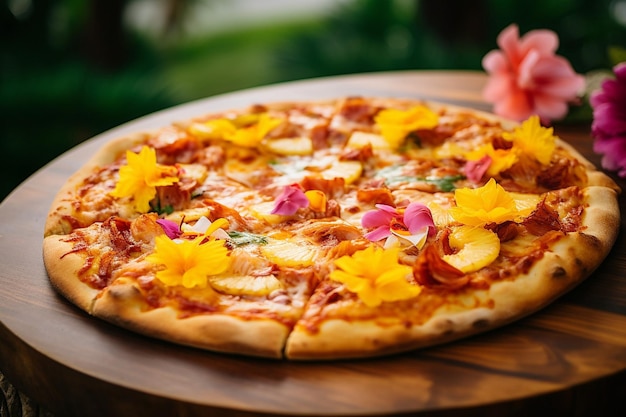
(43, 97, 620, 360)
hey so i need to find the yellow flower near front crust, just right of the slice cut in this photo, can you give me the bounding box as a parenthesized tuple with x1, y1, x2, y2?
(330, 245, 421, 307)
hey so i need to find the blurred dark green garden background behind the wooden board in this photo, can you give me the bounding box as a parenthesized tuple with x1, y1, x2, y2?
(0, 0, 626, 199)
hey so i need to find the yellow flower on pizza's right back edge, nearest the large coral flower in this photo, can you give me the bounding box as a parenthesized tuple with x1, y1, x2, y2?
(502, 116, 556, 165)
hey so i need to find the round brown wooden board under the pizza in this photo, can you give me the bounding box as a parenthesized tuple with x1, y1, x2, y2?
(0, 72, 626, 417)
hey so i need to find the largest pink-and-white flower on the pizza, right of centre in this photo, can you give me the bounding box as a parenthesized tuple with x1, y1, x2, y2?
(361, 203, 435, 248)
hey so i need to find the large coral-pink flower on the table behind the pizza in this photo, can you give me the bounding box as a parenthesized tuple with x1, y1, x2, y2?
(482, 24, 585, 122)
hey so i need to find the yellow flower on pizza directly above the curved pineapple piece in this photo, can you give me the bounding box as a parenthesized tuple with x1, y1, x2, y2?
(450, 178, 520, 226)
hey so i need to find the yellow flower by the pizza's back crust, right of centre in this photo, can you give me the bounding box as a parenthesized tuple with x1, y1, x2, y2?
(374, 106, 439, 149)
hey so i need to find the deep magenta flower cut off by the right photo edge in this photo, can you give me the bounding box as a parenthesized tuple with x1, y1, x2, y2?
(589, 62, 626, 178)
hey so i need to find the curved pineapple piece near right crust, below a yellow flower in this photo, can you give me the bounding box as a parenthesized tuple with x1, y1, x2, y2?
(443, 226, 500, 274)
